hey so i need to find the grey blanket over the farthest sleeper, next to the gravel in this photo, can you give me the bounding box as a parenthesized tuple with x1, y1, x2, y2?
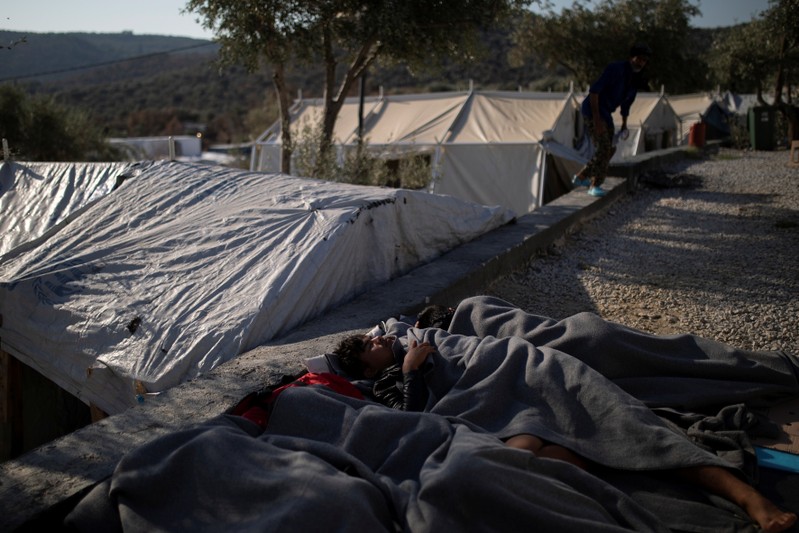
(449, 296, 799, 410)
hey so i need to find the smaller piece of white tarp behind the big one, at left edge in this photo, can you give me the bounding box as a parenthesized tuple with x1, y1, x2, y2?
(0, 161, 130, 256)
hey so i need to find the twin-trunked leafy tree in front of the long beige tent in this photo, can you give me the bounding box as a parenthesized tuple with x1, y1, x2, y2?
(186, 0, 531, 173)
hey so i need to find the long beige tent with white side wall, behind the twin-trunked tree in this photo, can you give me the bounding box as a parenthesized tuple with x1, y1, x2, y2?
(251, 91, 586, 214)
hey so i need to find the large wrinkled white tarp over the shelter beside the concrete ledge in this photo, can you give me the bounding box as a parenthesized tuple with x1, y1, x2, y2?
(0, 162, 512, 413)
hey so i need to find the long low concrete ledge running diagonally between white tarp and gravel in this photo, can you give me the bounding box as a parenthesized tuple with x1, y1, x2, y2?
(0, 150, 664, 531)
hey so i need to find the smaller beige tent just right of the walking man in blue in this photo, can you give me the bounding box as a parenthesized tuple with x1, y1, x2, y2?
(611, 93, 680, 163)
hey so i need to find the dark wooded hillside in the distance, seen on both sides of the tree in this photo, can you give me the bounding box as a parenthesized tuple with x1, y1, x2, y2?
(0, 31, 546, 142)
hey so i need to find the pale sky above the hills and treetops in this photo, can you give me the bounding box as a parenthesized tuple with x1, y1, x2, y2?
(0, 0, 768, 39)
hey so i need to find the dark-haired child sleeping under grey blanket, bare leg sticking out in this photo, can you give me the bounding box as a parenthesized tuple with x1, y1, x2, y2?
(333, 308, 797, 532)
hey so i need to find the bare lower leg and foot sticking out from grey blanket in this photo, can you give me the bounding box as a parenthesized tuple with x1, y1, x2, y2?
(676, 466, 797, 533)
